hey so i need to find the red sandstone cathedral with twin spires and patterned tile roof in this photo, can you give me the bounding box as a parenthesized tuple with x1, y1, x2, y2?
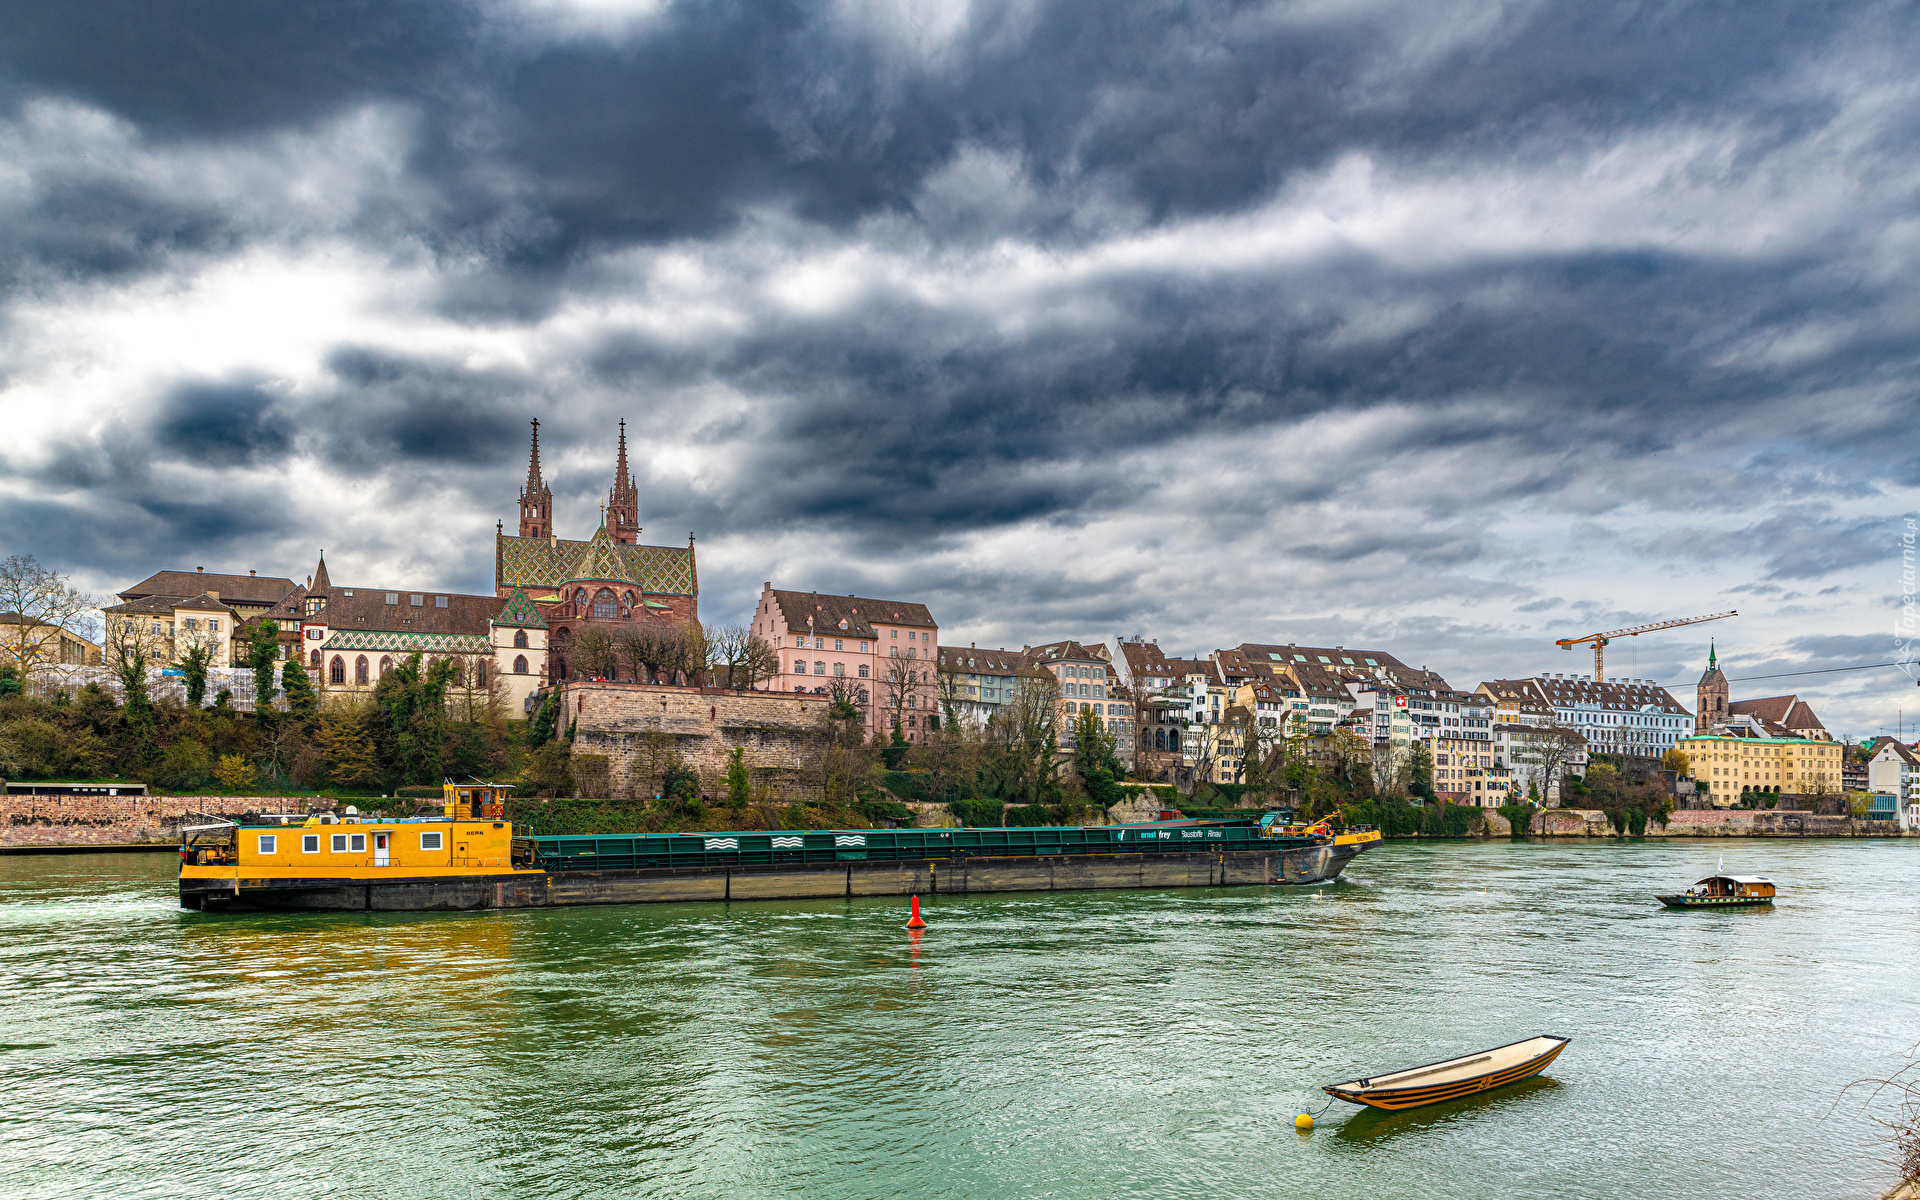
(493, 420, 701, 682)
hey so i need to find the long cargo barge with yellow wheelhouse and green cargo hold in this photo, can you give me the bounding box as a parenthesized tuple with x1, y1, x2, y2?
(180, 785, 1380, 912)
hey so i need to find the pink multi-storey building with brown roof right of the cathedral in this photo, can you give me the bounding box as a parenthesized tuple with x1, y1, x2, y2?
(753, 584, 941, 741)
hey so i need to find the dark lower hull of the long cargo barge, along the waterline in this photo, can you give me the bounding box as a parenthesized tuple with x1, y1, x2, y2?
(180, 845, 1365, 912)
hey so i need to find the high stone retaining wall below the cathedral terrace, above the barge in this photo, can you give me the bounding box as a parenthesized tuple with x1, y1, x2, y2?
(561, 684, 831, 803)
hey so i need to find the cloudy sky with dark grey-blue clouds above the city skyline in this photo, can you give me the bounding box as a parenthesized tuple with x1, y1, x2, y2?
(0, 0, 1920, 735)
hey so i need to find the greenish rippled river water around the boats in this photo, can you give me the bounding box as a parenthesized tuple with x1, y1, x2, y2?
(0, 839, 1920, 1200)
